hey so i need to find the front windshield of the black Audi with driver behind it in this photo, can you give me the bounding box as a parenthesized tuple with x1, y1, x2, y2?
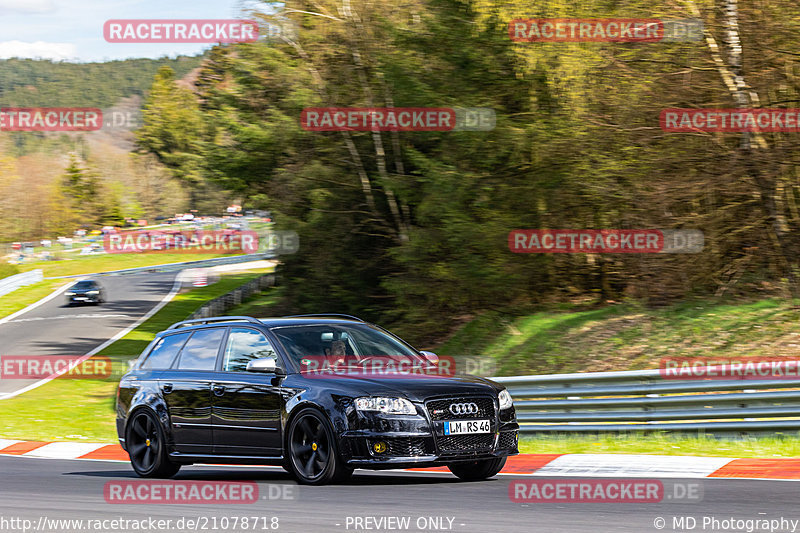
(272, 324, 425, 364)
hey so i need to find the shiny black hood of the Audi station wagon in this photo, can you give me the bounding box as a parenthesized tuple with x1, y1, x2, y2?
(290, 374, 503, 401)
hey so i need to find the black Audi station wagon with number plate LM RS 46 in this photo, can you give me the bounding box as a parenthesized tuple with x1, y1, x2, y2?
(117, 315, 519, 484)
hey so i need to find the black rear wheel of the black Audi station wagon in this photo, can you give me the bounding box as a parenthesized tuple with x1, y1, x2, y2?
(125, 410, 181, 478)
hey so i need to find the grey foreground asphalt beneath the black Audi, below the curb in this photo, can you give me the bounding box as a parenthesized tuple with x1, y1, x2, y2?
(0, 457, 800, 533)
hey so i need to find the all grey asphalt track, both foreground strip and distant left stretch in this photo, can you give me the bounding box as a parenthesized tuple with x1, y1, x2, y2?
(0, 273, 800, 533)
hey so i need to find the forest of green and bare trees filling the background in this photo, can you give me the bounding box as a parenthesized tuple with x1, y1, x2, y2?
(0, 0, 800, 339)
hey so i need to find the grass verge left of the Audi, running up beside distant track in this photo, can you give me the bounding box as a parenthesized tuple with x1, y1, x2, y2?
(0, 271, 276, 442)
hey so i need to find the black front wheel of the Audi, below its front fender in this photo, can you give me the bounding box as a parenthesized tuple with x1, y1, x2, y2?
(286, 408, 353, 485)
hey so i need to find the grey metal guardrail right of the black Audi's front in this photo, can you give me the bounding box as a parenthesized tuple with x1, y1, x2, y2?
(492, 367, 800, 435)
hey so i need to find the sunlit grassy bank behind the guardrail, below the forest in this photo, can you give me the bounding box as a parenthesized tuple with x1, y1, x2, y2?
(436, 299, 800, 375)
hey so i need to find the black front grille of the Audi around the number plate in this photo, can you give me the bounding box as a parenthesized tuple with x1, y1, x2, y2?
(426, 396, 497, 455)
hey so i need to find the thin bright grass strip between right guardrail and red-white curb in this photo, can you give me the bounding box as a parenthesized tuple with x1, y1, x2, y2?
(519, 434, 800, 457)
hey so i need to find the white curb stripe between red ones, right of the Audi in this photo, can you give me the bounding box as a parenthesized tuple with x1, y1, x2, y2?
(534, 454, 733, 478)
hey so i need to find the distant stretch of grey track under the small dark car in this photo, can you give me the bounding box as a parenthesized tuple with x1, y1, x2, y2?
(0, 272, 177, 396)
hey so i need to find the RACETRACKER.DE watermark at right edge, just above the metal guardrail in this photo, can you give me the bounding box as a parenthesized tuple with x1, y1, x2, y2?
(658, 357, 800, 380)
